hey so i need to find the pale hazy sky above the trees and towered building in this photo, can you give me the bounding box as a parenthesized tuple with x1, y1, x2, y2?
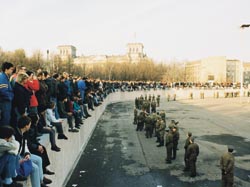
(0, 0, 250, 62)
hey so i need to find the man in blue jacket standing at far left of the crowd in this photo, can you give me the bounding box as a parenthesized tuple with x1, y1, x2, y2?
(0, 62, 14, 126)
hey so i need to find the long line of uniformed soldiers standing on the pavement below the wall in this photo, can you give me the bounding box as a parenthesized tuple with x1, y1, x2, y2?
(133, 95, 234, 187)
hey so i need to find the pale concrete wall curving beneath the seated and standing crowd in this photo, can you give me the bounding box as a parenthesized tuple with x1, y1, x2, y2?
(23, 89, 248, 187)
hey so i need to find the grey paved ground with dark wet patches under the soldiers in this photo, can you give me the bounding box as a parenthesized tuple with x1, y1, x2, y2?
(67, 98, 250, 187)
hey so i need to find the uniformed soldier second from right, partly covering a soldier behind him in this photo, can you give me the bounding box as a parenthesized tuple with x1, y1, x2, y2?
(187, 137, 199, 177)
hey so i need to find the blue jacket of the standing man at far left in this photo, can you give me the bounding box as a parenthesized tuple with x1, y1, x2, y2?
(0, 72, 14, 102)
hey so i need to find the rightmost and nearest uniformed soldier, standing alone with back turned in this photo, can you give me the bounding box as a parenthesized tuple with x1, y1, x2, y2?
(220, 146, 234, 187)
